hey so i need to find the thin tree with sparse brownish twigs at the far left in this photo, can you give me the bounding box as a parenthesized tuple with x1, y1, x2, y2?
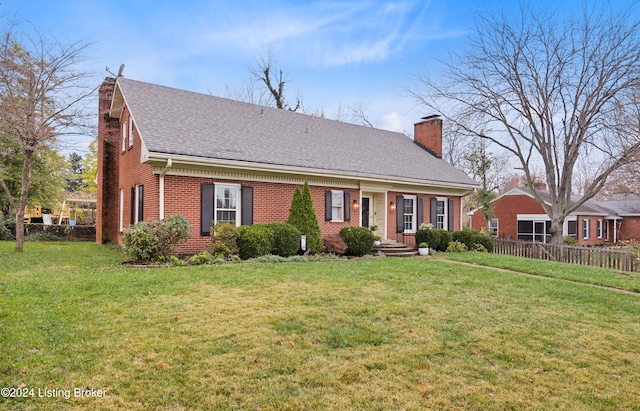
(0, 25, 94, 251)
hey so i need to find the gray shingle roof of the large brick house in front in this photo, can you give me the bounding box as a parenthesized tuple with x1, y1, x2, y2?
(117, 77, 477, 186)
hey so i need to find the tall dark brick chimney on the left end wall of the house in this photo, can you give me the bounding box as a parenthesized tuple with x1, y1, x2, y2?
(96, 77, 120, 244)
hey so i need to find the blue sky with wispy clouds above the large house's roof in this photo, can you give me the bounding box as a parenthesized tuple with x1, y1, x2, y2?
(0, 0, 628, 154)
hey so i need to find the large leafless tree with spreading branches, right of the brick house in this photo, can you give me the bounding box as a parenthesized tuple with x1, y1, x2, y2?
(413, 4, 640, 243)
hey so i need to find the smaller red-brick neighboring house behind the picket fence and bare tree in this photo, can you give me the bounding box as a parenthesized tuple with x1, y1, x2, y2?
(469, 184, 640, 245)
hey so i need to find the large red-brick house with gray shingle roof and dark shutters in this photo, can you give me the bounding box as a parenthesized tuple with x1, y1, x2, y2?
(96, 76, 477, 253)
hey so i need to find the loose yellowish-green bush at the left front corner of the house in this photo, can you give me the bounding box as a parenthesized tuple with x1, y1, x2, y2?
(122, 215, 191, 263)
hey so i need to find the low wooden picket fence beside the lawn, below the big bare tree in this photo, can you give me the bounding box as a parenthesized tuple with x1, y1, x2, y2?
(492, 238, 640, 271)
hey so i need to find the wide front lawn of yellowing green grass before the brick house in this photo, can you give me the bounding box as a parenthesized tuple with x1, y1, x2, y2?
(0, 242, 640, 410)
